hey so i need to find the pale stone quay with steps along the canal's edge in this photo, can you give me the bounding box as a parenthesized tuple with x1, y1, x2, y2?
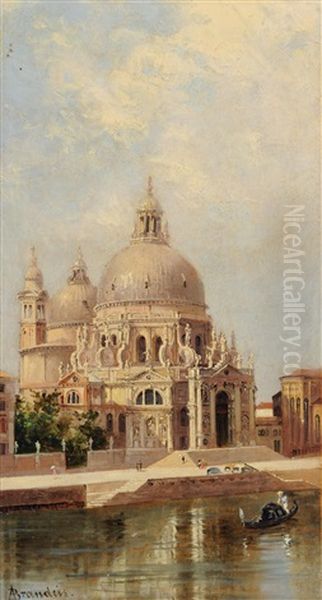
(0, 448, 321, 512)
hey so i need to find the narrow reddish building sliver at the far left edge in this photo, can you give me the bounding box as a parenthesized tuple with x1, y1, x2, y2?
(0, 371, 16, 455)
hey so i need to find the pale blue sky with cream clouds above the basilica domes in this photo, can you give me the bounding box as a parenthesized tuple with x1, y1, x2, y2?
(1, 0, 321, 401)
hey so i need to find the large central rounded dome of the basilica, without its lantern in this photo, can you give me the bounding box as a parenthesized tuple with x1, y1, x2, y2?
(98, 242, 205, 305)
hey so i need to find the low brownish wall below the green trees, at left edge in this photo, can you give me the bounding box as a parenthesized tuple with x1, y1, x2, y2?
(0, 452, 66, 475)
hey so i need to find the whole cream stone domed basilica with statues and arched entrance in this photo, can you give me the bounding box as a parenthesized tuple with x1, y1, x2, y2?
(18, 179, 256, 451)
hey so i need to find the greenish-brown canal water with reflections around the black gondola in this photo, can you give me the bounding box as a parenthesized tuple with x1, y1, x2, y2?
(0, 492, 321, 600)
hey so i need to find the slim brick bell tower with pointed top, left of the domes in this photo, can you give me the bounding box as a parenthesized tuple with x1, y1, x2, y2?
(17, 247, 48, 350)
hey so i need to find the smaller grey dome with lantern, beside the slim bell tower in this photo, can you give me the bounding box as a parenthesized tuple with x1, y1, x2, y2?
(48, 250, 97, 323)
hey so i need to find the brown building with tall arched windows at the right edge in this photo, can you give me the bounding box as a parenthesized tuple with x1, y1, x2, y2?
(273, 369, 322, 456)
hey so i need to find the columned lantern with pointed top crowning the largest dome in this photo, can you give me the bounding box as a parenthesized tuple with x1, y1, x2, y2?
(132, 175, 168, 244)
